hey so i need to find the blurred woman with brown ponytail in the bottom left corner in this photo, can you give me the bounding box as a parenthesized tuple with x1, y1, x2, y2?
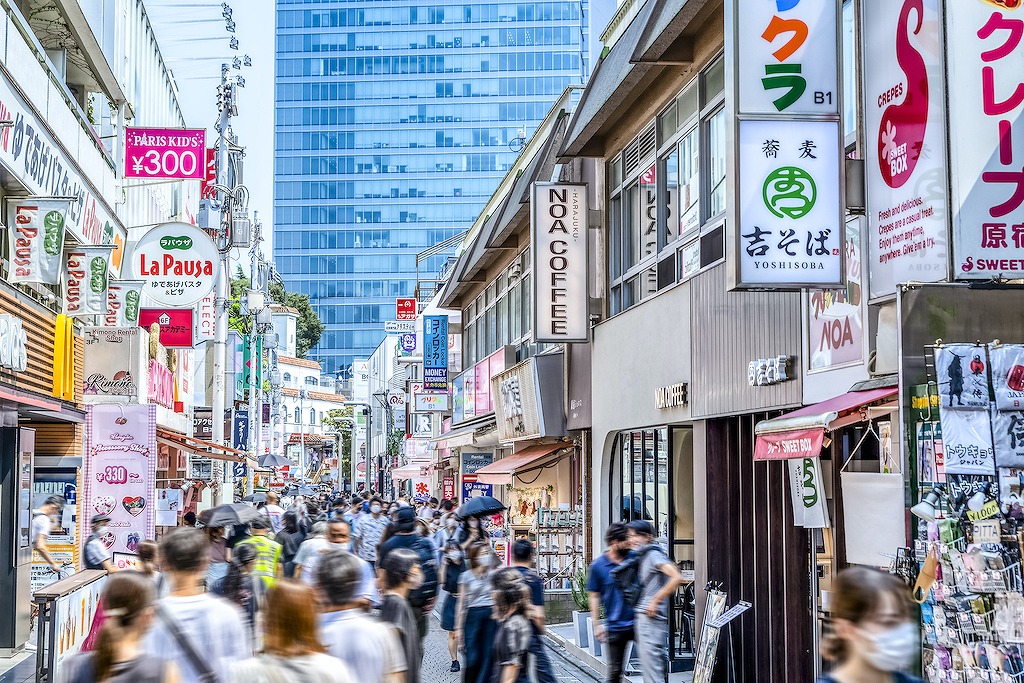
(57, 571, 178, 683)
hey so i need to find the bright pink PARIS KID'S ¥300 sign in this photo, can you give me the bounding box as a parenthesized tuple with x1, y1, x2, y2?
(125, 128, 207, 180)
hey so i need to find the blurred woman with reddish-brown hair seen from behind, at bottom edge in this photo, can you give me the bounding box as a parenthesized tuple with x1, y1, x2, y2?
(230, 581, 355, 683)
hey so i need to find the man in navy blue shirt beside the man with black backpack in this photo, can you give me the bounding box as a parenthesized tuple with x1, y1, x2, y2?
(587, 522, 634, 683)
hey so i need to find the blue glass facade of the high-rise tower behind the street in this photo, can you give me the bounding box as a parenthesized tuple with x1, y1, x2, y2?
(273, 0, 589, 373)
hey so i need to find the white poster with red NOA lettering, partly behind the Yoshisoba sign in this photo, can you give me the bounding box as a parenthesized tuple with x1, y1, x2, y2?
(807, 218, 864, 373)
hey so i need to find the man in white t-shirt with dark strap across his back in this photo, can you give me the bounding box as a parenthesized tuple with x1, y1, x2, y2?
(142, 528, 253, 681)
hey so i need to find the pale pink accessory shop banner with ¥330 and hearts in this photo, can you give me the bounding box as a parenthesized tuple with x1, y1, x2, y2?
(81, 404, 157, 554)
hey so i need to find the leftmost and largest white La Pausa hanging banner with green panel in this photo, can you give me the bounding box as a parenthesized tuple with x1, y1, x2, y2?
(7, 198, 71, 285)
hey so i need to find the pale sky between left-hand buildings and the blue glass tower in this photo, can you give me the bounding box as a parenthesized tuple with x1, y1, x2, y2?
(144, 0, 274, 258)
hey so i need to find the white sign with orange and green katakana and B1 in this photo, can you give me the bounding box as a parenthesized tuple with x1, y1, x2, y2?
(733, 0, 840, 115)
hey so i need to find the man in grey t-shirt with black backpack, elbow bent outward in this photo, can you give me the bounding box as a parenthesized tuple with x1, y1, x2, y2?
(629, 519, 683, 683)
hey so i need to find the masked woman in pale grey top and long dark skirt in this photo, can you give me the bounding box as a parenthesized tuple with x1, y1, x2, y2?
(455, 543, 498, 683)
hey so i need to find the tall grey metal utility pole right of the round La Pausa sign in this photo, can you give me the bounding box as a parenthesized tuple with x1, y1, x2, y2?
(212, 65, 234, 505)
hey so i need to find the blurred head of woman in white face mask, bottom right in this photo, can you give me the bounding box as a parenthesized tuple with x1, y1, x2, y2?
(820, 567, 921, 683)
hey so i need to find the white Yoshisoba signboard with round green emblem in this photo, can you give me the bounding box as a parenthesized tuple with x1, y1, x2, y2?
(738, 120, 844, 286)
